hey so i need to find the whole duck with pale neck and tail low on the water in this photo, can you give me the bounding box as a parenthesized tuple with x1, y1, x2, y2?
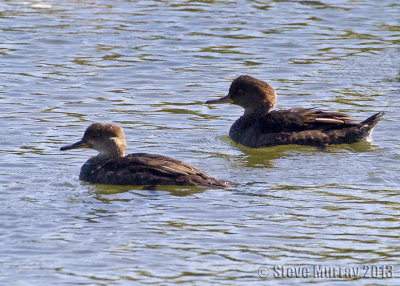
(60, 123, 233, 187)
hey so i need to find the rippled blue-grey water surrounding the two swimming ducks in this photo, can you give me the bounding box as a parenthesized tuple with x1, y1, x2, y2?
(0, 0, 400, 285)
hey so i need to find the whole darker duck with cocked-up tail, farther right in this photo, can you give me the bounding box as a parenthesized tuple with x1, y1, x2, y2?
(206, 75, 384, 148)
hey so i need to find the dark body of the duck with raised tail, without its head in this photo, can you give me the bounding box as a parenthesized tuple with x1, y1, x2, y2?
(229, 108, 383, 148)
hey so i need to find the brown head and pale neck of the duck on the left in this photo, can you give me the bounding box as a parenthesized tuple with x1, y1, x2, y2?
(60, 123, 126, 158)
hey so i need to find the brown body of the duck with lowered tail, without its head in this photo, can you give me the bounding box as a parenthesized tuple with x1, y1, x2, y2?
(79, 153, 228, 187)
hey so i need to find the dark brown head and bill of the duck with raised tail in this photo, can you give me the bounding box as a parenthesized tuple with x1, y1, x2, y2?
(206, 75, 277, 114)
